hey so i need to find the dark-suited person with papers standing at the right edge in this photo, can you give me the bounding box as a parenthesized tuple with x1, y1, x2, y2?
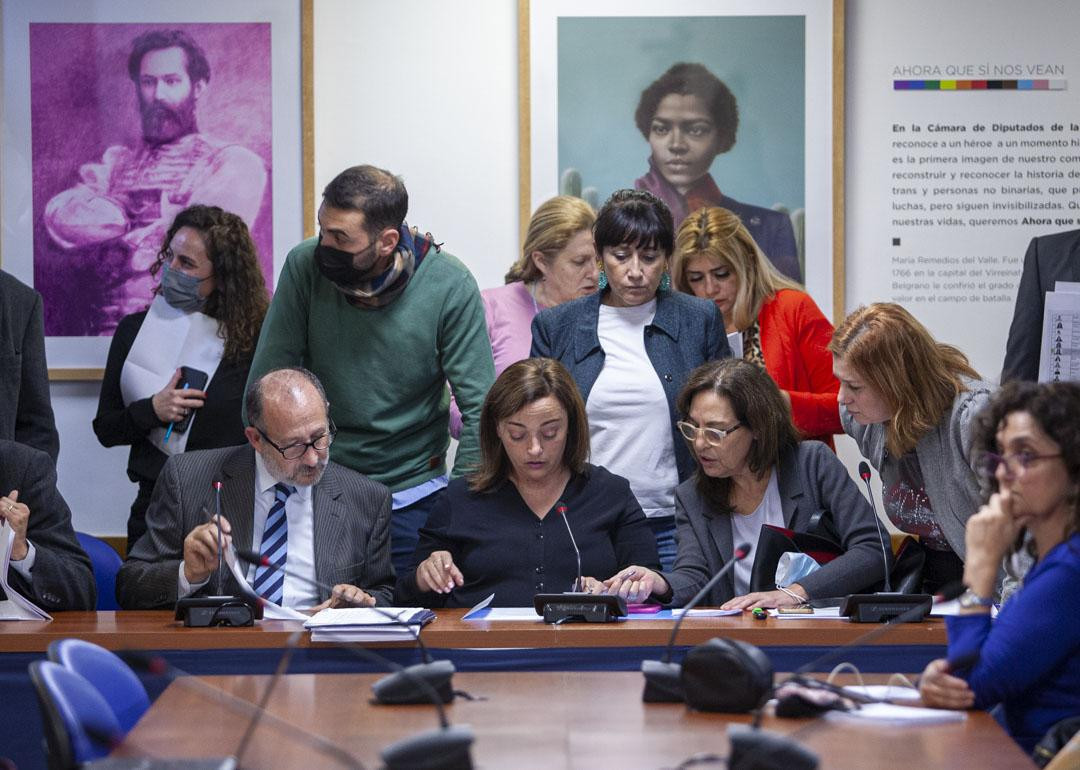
(1001, 230, 1080, 382)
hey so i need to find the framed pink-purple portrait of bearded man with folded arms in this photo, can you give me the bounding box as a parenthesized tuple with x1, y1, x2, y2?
(0, 0, 303, 378)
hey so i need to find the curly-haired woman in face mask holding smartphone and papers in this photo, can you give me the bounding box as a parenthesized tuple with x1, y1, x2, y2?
(94, 205, 269, 550)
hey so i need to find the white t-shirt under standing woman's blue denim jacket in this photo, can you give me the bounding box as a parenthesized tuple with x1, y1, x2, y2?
(585, 299, 678, 517)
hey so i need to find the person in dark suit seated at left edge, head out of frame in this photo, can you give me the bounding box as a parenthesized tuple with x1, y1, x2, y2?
(0, 438, 97, 612)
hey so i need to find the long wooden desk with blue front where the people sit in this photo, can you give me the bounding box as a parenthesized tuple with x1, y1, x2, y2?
(0, 610, 946, 768)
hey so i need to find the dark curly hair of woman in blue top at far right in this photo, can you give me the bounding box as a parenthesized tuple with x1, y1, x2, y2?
(971, 380, 1080, 545)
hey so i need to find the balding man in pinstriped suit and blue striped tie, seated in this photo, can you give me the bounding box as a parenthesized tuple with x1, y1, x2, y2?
(117, 368, 394, 609)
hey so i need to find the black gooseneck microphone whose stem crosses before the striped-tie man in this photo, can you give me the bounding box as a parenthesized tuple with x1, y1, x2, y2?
(237, 549, 455, 705)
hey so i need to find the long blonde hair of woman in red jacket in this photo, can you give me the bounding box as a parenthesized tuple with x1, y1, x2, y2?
(672, 206, 802, 330)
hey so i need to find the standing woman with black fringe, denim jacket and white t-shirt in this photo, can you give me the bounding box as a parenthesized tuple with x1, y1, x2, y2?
(531, 190, 731, 569)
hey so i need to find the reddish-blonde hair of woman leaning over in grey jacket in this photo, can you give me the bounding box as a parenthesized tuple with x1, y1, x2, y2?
(828, 302, 978, 457)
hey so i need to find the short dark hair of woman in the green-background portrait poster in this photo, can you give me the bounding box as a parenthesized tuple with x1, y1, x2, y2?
(634, 62, 739, 153)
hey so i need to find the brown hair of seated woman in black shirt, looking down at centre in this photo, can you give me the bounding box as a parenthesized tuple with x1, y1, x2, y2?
(469, 359, 589, 491)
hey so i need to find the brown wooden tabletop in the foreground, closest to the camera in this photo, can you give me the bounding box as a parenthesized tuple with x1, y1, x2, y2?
(118, 672, 1034, 770)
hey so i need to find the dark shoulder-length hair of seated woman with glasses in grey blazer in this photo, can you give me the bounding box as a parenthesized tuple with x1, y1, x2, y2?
(676, 359, 799, 513)
